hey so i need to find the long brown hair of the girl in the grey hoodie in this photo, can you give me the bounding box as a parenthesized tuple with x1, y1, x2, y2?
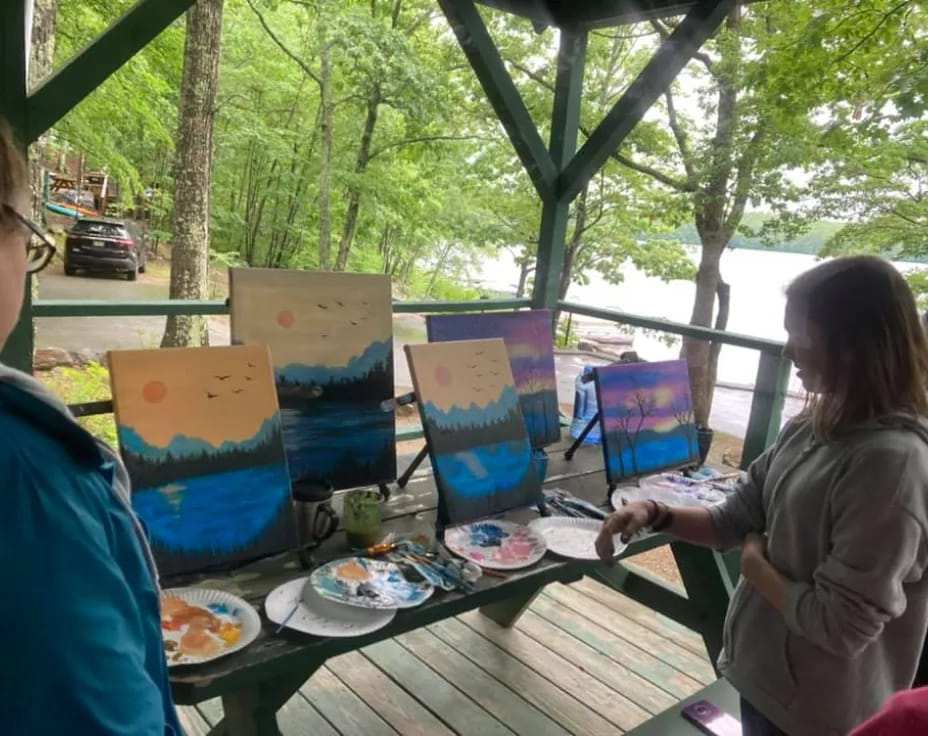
(786, 256, 928, 440)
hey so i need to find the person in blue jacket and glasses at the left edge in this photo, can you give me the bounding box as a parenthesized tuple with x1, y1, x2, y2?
(0, 119, 183, 736)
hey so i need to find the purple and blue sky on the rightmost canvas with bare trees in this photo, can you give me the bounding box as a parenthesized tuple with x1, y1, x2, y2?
(598, 360, 692, 432)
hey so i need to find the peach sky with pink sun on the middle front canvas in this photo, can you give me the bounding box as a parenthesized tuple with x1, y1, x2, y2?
(406, 338, 513, 411)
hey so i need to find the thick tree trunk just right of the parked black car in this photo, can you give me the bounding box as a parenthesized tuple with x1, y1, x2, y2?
(161, 0, 223, 347)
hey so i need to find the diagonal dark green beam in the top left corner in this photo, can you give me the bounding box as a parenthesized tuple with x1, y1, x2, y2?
(26, 0, 195, 143)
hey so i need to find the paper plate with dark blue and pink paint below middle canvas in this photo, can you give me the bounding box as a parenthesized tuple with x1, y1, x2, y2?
(445, 521, 546, 570)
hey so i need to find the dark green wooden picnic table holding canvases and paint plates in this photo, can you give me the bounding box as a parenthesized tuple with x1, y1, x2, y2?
(165, 444, 731, 736)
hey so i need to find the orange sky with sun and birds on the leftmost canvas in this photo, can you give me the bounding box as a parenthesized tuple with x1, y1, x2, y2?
(109, 346, 277, 447)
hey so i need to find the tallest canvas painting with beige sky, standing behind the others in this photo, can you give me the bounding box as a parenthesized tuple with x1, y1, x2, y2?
(229, 269, 396, 497)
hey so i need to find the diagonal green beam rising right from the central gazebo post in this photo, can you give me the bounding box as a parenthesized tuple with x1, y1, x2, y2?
(557, 0, 736, 202)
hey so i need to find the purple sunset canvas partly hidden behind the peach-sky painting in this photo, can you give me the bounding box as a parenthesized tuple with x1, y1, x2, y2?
(426, 309, 561, 447)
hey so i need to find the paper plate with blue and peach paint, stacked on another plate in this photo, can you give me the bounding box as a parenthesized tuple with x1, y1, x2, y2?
(310, 557, 435, 610)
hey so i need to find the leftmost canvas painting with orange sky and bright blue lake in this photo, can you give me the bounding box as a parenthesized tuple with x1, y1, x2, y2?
(109, 347, 296, 575)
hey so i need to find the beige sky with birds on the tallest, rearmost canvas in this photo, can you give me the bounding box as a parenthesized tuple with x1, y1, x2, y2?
(230, 268, 393, 368)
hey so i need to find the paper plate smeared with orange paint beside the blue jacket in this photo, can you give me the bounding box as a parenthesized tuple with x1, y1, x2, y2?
(161, 588, 261, 667)
